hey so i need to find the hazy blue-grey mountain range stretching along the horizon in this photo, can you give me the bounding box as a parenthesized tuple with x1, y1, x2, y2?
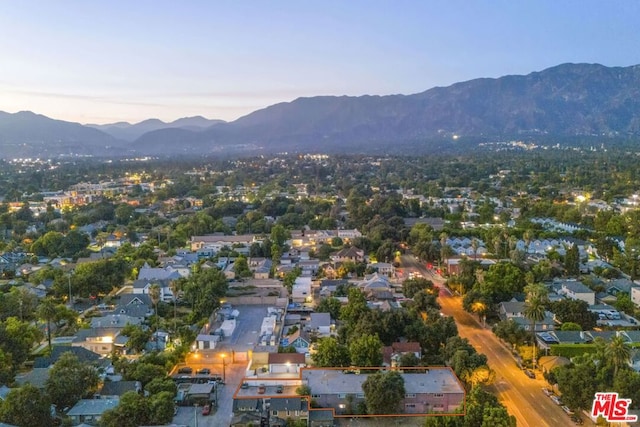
(0, 64, 640, 158)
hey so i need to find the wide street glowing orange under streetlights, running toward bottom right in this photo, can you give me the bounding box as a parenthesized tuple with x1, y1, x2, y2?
(402, 256, 590, 427)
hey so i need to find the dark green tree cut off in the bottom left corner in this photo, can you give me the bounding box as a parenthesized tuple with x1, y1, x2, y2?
(0, 384, 53, 427)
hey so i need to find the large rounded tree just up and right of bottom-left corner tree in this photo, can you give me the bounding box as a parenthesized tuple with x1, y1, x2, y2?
(45, 352, 99, 408)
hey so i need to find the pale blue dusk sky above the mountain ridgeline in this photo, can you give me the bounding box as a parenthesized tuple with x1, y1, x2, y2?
(0, 0, 640, 124)
